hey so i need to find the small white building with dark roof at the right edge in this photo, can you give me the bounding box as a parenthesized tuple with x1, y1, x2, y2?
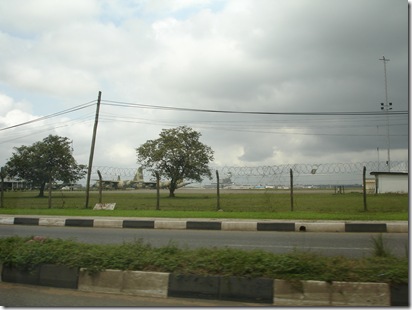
(371, 172, 409, 194)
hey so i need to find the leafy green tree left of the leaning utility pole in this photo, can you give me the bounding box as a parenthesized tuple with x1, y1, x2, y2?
(6, 135, 86, 207)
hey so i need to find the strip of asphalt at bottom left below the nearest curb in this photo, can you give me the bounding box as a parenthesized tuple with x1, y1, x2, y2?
(0, 282, 268, 308)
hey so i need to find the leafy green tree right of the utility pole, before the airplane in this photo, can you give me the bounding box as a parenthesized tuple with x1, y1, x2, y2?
(136, 126, 213, 197)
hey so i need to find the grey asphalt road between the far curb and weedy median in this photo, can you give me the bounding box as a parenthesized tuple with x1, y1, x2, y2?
(0, 225, 409, 258)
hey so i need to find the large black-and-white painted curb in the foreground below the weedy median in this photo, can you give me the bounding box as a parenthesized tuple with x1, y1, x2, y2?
(0, 264, 409, 307)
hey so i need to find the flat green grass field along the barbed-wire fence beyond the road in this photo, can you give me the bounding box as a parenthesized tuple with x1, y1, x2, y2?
(0, 190, 408, 221)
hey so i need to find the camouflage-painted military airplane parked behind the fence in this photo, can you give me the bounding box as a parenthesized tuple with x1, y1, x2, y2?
(94, 167, 190, 189)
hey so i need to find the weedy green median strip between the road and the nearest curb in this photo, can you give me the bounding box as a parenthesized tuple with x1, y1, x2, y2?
(0, 237, 408, 283)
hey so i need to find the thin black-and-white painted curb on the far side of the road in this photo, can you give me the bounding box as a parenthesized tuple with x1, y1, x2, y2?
(0, 215, 409, 233)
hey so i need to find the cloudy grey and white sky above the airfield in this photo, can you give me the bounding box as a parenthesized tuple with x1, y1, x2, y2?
(0, 0, 409, 179)
